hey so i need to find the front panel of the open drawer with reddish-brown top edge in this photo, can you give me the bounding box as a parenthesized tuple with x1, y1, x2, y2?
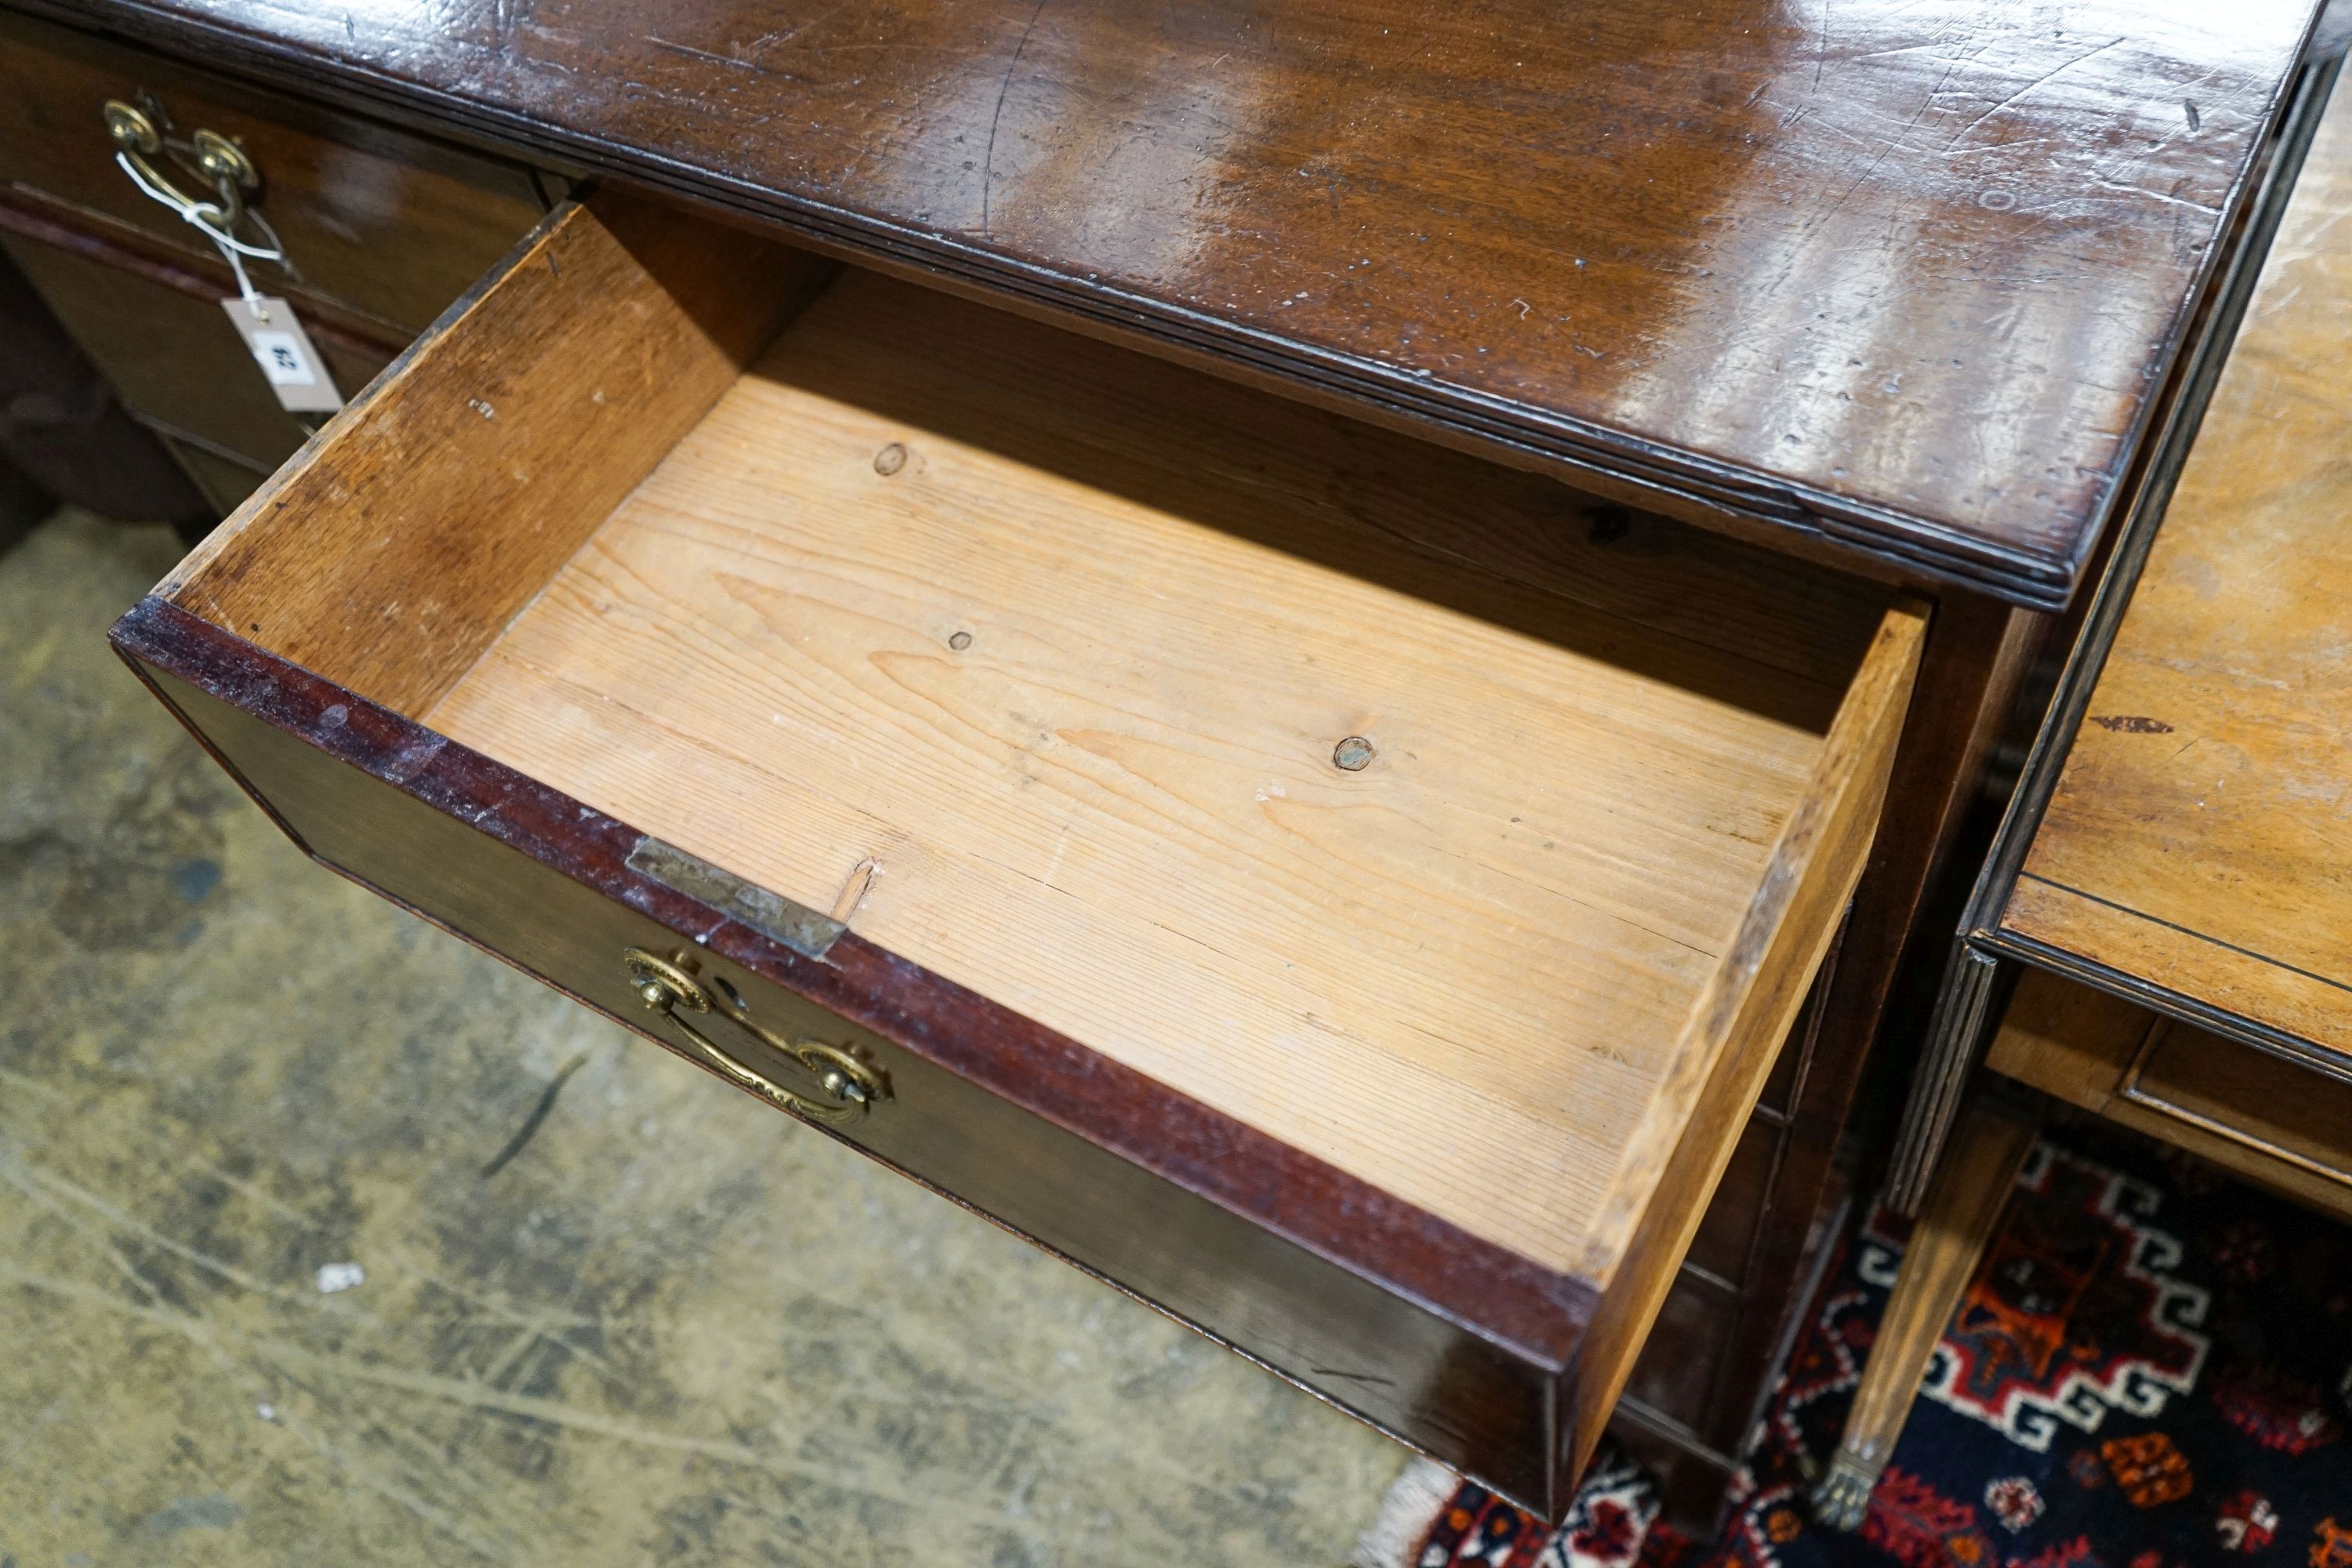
(118, 604, 1592, 1507)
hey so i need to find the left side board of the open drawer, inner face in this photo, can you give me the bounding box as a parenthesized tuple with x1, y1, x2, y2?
(158, 198, 818, 710)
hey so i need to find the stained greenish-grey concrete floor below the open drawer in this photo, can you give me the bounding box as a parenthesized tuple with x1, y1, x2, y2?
(0, 513, 1404, 1568)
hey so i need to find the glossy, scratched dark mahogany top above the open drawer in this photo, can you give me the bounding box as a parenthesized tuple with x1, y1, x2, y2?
(36, 0, 2314, 604)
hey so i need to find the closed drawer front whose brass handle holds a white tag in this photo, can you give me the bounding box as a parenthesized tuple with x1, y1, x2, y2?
(0, 16, 543, 336)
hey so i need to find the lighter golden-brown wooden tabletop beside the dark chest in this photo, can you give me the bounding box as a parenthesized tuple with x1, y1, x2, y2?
(1999, 70, 2352, 1053)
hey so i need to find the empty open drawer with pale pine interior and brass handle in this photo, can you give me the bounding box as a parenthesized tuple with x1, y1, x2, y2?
(101, 187, 1922, 1512)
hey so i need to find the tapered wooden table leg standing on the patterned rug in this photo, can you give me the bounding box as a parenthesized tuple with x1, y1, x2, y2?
(1813, 1102, 2034, 1530)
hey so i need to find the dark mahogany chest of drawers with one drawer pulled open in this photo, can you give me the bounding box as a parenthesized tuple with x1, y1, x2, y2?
(12, 0, 2310, 1512)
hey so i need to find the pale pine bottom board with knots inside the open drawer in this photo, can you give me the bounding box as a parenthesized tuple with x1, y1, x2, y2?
(430, 263, 1900, 1267)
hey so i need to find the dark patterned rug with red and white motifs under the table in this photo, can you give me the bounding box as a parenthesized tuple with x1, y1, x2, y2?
(1355, 1131, 2352, 1568)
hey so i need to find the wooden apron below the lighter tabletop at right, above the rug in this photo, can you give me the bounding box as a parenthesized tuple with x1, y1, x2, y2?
(1985, 968, 2352, 1218)
